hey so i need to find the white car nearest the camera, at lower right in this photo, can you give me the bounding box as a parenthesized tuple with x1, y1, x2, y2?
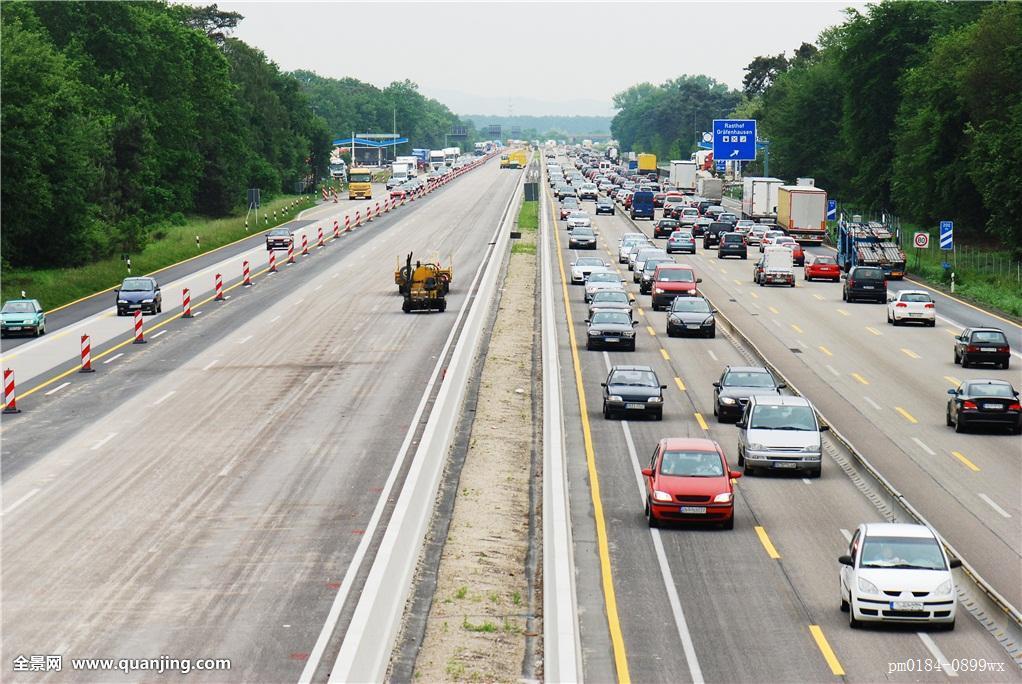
(838, 522, 962, 630)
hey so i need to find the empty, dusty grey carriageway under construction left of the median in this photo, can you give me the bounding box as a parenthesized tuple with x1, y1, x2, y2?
(2, 162, 519, 682)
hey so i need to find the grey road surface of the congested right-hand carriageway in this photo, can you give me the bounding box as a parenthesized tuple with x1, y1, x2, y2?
(544, 152, 1022, 682)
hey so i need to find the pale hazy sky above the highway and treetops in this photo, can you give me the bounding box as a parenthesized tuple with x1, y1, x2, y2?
(221, 1, 865, 115)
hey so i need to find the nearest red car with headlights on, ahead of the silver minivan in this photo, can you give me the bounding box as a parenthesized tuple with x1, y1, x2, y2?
(642, 438, 742, 530)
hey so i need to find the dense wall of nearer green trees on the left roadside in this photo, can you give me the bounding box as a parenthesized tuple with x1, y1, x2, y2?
(0, 2, 328, 267)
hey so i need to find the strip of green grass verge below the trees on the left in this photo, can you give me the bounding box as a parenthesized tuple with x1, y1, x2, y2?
(0, 195, 313, 311)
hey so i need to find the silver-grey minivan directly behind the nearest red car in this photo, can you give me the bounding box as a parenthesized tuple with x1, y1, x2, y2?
(735, 395, 830, 477)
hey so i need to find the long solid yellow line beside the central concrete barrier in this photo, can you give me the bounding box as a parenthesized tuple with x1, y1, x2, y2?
(547, 190, 632, 684)
